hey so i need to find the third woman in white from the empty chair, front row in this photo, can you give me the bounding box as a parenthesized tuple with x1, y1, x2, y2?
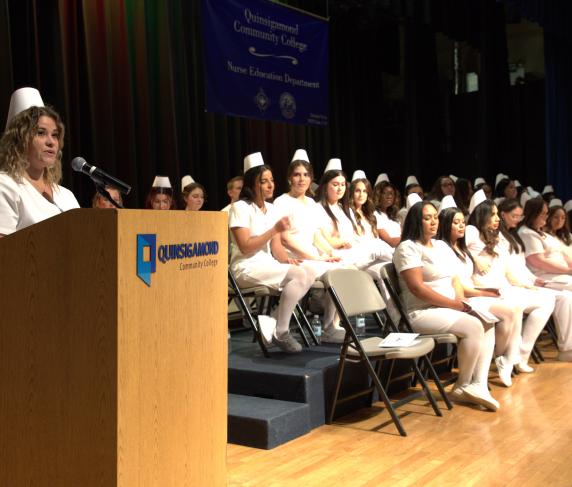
(465, 194, 554, 385)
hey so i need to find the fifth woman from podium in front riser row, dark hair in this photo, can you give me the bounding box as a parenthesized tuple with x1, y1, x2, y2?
(370, 181, 401, 247)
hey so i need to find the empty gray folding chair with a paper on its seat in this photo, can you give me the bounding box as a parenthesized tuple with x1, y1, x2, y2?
(322, 269, 450, 436)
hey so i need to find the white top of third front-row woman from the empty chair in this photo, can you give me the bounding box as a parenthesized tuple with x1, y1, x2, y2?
(465, 225, 510, 288)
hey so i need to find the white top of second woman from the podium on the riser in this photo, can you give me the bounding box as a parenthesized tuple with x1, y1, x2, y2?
(274, 193, 320, 256)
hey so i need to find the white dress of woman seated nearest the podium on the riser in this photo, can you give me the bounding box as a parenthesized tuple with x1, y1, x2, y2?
(228, 201, 290, 289)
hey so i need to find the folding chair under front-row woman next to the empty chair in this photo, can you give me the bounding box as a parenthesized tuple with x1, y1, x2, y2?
(381, 263, 457, 385)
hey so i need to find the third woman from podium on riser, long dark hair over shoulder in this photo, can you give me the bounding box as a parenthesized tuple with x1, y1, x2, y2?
(316, 170, 391, 269)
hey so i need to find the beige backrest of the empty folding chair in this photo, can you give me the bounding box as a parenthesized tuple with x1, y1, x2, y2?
(322, 269, 385, 316)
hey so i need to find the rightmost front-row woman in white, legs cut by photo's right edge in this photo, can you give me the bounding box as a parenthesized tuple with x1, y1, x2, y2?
(518, 198, 572, 362)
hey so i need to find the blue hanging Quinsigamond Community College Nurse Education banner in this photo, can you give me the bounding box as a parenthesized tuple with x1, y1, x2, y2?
(202, 0, 328, 126)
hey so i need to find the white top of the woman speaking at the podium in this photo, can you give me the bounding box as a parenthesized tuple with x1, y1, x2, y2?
(0, 172, 79, 235)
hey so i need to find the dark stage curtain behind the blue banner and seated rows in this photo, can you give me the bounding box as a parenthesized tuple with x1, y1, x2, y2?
(0, 0, 556, 209)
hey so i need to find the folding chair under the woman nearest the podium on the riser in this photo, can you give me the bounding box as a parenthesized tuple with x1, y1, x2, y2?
(228, 268, 318, 357)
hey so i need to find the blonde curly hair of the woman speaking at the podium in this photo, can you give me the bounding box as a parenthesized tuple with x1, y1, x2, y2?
(0, 107, 65, 186)
